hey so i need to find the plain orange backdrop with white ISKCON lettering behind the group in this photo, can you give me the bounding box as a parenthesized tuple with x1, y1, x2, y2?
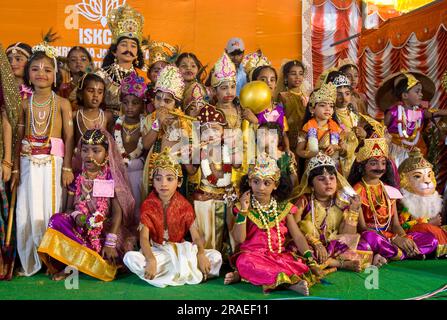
(0, 0, 302, 72)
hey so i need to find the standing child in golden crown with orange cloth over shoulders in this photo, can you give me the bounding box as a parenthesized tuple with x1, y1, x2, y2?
(296, 82, 346, 167)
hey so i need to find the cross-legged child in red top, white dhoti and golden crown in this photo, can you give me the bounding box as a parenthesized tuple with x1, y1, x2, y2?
(124, 149, 222, 288)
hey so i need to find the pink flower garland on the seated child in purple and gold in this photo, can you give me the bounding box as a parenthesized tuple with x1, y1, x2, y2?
(74, 168, 110, 252)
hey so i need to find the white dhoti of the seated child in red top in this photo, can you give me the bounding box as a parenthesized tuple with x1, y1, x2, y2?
(123, 241, 222, 288)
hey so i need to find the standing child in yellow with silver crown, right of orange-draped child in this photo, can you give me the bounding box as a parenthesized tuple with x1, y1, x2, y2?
(331, 72, 366, 177)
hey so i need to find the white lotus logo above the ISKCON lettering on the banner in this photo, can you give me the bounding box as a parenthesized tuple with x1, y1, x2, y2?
(76, 0, 126, 28)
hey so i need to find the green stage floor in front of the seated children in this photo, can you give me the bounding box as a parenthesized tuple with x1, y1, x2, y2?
(0, 259, 447, 300)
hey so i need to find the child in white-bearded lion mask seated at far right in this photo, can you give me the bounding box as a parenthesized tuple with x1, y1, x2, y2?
(399, 148, 447, 257)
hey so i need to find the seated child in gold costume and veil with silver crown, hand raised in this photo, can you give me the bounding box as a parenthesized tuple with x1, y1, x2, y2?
(292, 153, 372, 273)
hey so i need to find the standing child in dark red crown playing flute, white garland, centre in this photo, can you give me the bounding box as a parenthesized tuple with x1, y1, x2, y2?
(193, 104, 236, 258)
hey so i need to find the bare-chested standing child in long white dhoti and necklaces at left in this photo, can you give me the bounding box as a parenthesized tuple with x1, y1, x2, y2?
(12, 33, 74, 276)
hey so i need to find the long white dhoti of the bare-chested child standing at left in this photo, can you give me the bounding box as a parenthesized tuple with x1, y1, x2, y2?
(16, 154, 63, 276)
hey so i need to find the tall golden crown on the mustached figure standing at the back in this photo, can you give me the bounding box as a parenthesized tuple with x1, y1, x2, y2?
(107, 3, 144, 44)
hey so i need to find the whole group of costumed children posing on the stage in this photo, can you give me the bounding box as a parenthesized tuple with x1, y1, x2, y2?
(2, 4, 447, 295)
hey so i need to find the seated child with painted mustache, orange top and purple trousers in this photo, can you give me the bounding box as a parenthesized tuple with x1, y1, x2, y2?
(348, 124, 438, 267)
